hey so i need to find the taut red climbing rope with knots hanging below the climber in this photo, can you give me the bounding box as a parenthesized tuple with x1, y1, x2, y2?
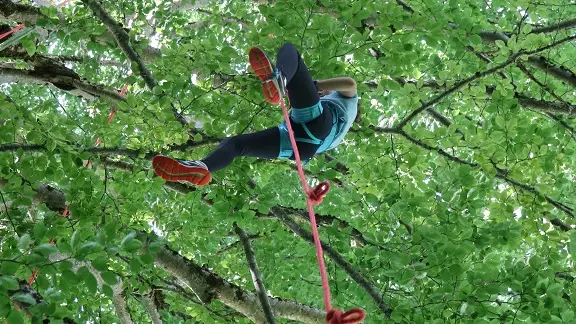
(280, 98, 366, 324)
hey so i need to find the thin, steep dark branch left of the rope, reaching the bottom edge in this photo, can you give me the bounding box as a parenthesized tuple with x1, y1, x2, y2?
(233, 222, 276, 324)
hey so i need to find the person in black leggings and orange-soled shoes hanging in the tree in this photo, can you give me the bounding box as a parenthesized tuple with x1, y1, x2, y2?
(152, 43, 358, 186)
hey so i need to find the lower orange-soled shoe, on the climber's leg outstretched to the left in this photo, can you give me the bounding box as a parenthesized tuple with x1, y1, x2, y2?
(152, 155, 211, 186)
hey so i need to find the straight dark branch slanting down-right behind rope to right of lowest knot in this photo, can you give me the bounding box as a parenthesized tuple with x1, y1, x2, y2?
(271, 207, 392, 317)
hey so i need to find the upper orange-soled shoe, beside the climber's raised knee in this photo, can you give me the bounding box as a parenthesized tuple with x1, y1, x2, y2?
(248, 47, 286, 105)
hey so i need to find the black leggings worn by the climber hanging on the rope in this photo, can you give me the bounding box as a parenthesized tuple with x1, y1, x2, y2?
(202, 43, 332, 172)
